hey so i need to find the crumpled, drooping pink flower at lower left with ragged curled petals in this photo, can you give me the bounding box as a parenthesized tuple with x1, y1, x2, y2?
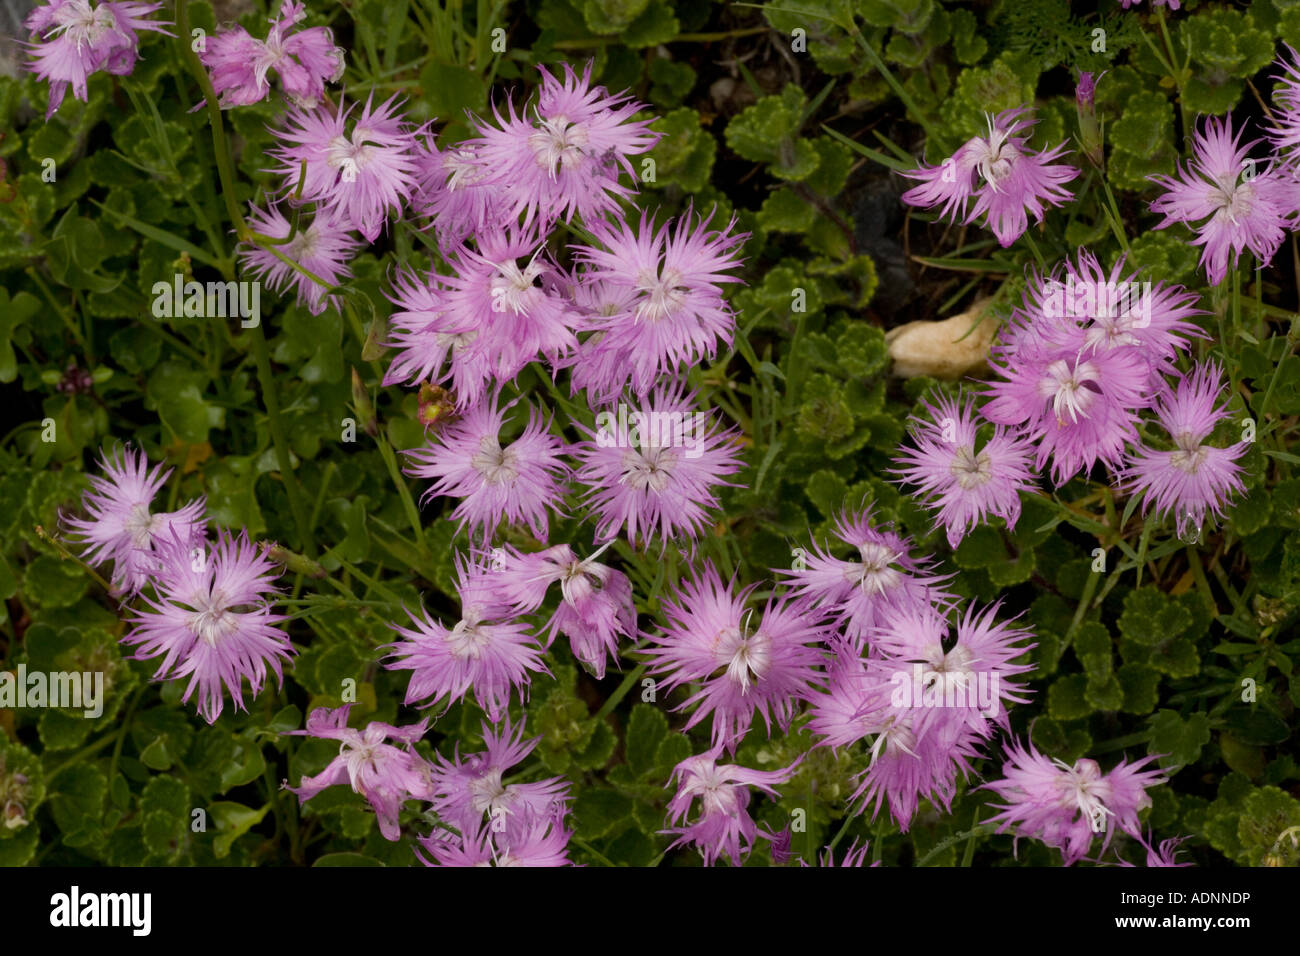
(286, 704, 433, 840)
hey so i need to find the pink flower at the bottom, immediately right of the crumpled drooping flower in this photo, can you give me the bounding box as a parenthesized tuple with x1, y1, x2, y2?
(432, 721, 569, 835)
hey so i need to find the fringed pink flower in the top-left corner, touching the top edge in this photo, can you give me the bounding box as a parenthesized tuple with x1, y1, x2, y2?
(25, 0, 173, 120)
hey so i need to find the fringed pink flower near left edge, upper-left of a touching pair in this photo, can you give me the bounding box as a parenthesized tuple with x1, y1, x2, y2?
(64, 449, 207, 594)
